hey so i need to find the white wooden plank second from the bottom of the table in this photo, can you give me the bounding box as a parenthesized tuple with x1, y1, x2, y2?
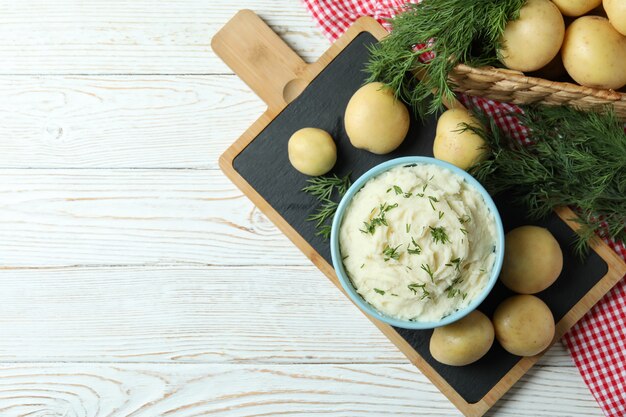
(0, 266, 573, 368)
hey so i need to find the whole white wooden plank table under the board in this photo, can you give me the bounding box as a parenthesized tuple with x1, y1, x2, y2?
(0, 0, 601, 417)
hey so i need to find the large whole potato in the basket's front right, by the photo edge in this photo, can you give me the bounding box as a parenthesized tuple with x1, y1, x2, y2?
(561, 16, 626, 90)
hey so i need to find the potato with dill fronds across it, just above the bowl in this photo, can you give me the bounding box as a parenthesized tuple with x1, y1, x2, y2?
(433, 108, 487, 170)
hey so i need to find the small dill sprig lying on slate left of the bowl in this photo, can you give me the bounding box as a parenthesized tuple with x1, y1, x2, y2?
(302, 173, 352, 239)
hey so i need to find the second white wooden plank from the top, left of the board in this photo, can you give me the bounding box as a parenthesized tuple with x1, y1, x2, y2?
(0, 75, 260, 168)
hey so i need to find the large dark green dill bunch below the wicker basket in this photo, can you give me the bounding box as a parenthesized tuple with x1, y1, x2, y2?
(466, 106, 626, 255)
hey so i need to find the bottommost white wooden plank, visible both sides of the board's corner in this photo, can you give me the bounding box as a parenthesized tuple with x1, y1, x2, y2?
(0, 363, 602, 417)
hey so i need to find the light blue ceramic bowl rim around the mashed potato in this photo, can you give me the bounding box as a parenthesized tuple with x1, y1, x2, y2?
(330, 156, 504, 329)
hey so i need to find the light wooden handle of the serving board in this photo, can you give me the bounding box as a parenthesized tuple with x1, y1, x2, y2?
(211, 10, 308, 109)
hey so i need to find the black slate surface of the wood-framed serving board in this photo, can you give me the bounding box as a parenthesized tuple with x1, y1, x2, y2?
(233, 33, 608, 404)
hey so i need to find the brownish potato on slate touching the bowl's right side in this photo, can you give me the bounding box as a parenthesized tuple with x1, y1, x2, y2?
(500, 226, 563, 294)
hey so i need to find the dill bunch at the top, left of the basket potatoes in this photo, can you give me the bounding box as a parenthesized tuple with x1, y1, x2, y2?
(367, 0, 526, 117)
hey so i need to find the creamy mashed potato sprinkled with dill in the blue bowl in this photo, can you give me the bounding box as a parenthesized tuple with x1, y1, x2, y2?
(339, 164, 496, 322)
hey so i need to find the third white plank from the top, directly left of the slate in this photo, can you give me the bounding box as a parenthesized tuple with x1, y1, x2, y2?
(0, 169, 309, 268)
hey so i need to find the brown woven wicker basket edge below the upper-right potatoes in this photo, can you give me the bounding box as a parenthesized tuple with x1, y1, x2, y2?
(450, 64, 626, 122)
